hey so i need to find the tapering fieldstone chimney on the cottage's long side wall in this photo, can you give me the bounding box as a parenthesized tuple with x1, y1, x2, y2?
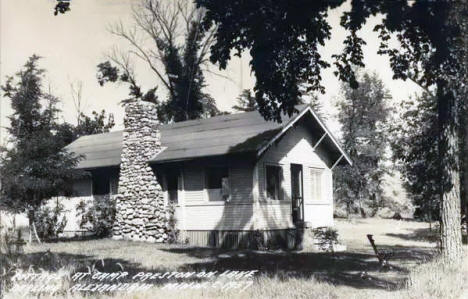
(113, 100, 169, 242)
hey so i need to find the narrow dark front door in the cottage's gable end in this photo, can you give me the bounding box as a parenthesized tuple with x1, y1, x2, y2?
(291, 164, 304, 225)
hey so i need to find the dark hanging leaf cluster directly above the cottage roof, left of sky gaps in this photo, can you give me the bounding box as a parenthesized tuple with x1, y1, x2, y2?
(196, 0, 344, 121)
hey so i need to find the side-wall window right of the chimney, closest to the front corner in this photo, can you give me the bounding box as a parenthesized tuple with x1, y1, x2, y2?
(206, 167, 230, 201)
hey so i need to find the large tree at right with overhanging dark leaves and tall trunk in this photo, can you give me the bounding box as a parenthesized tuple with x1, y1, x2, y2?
(195, 0, 468, 264)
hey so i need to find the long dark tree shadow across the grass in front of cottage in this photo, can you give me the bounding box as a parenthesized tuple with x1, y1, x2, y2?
(14, 242, 431, 289)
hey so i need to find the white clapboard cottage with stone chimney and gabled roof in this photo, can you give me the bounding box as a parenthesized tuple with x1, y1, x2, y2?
(68, 101, 351, 246)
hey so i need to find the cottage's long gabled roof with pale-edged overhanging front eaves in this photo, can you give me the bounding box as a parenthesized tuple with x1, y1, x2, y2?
(67, 105, 350, 169)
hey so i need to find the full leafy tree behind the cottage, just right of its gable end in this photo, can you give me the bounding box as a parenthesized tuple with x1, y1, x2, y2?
(335, 73, 391, 217)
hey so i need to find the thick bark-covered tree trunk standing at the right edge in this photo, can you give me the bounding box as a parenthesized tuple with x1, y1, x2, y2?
(437, 81, 463, 265)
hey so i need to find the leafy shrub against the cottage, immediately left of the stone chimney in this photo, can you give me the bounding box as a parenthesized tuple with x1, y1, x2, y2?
(76, 195, 115, 237)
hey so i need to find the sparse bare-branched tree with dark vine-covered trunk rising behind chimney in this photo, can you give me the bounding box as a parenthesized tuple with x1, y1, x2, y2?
(98, 0, 220, 122)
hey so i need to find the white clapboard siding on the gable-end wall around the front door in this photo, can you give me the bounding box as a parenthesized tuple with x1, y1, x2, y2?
(257, 125, 333, 229)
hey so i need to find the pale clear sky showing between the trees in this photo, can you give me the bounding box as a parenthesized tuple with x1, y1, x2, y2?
(0, 0, 420, 144)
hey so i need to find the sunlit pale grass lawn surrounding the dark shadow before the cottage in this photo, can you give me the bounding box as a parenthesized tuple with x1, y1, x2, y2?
(7, 219, 468, 298)
